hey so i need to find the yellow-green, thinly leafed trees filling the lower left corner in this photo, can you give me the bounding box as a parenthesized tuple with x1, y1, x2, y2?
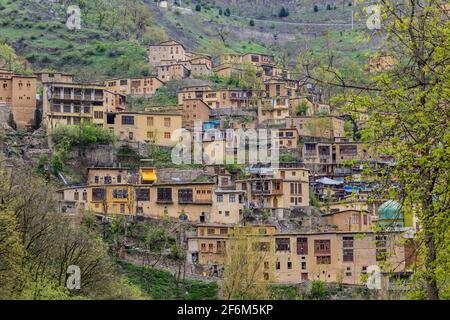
(0, 167, 146, 300)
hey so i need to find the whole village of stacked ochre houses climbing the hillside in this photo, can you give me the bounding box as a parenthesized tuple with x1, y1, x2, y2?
(0, 33, 418, 298)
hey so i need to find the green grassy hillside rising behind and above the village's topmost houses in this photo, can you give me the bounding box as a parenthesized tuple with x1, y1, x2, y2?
(0, 0, 371, 81)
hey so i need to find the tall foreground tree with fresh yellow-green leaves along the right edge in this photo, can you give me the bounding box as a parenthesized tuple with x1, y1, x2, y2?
(346, 0, 450, 299)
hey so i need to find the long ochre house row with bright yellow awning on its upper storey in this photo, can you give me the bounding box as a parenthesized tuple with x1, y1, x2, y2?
(60, 167, 244, 224)
